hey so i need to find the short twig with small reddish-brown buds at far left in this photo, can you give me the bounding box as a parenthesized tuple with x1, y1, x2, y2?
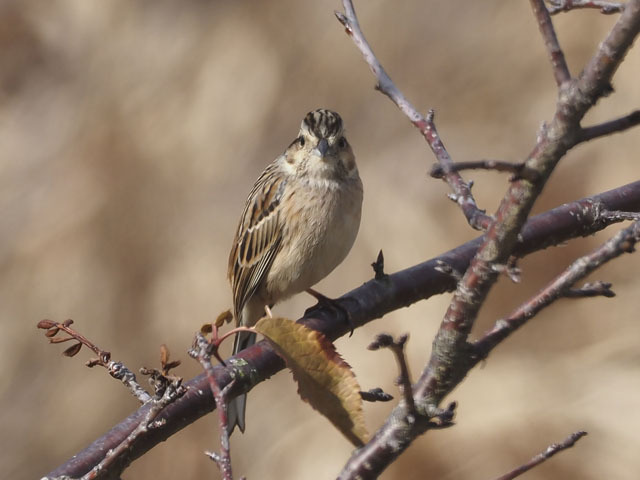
(38, 319, 151, 404)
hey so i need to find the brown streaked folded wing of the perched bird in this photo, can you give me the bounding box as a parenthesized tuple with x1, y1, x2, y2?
(228, 162, 286, 321)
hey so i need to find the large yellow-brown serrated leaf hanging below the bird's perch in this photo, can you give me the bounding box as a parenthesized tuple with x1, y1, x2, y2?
(255, 318, 368, 447)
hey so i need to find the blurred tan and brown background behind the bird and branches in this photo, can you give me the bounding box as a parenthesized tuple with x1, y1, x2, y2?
(0, 0, 640, 479)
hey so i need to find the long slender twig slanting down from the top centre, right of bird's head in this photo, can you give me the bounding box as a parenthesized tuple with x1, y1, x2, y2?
(335, 0, 491, 230)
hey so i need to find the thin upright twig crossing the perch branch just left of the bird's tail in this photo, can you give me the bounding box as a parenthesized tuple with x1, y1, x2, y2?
(189, 332, 239, 480)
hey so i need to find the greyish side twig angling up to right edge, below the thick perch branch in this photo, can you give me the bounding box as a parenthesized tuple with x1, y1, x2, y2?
(473, 221, 640, 358)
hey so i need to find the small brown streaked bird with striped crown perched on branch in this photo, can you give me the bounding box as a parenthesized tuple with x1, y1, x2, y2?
(228, 109, 362, 432)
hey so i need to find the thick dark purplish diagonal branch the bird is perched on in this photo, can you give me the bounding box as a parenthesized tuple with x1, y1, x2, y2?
(48, 181, 640, 478)
